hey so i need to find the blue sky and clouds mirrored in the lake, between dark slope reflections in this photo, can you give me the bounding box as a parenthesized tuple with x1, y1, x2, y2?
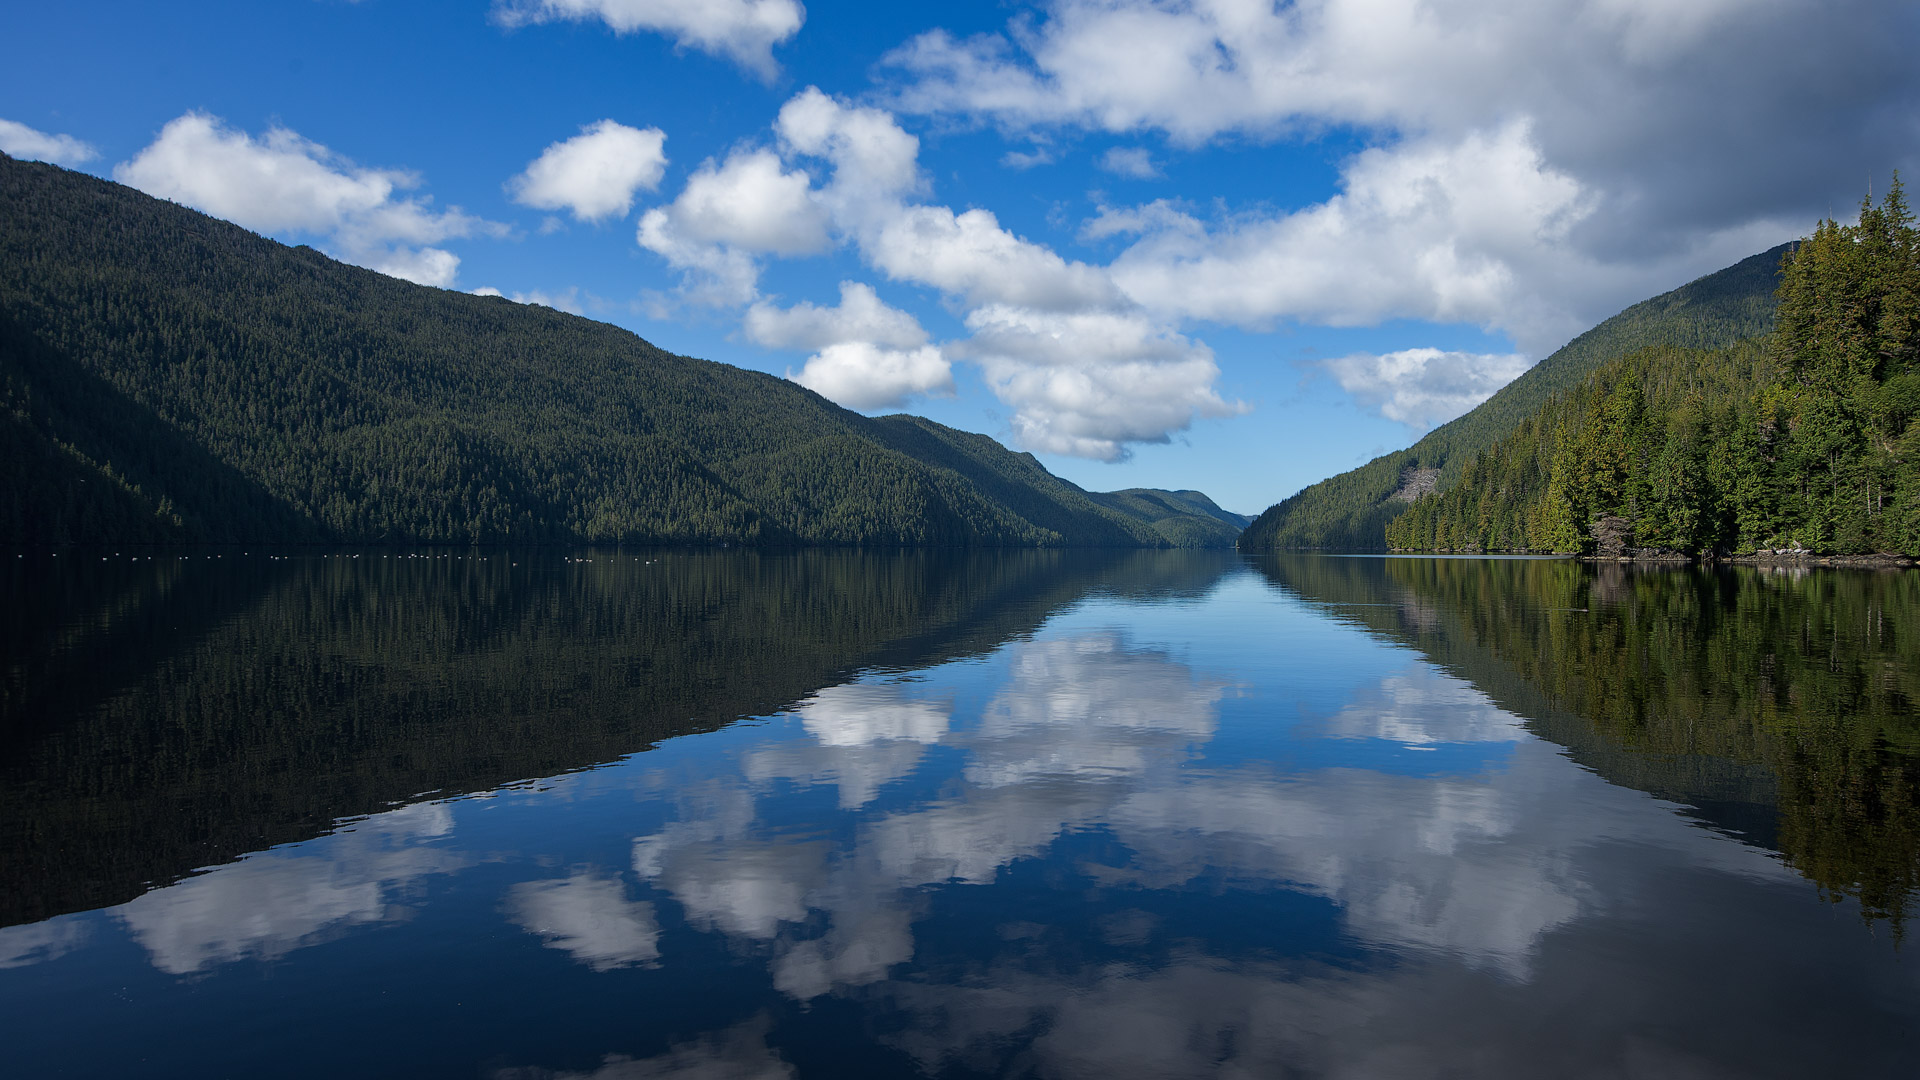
(0, 575, 1920, 1078)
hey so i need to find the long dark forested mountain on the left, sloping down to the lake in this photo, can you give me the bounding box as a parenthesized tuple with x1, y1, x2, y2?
(0, 156, 1231, 548)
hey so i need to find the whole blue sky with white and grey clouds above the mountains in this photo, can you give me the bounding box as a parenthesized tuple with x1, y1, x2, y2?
(0, 0, 1920, 513)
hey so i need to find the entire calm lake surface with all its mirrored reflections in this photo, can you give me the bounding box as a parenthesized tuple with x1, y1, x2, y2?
(0, 552, 1920, 1078)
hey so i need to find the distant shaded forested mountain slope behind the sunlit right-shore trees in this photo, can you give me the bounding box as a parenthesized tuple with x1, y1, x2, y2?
(1240, 244, 1788, 552)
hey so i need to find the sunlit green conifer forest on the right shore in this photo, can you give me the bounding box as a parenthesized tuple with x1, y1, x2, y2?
(1386, 183, 1920, 555)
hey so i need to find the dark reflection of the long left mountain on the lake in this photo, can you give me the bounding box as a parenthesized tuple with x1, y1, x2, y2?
(0, 550, 1231, 924)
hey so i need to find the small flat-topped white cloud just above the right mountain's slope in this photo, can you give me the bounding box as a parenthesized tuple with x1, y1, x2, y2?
(1327, 348, 1530, 432)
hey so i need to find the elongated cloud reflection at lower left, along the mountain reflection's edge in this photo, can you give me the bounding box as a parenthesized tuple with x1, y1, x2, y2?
(115, 803, 468, 974)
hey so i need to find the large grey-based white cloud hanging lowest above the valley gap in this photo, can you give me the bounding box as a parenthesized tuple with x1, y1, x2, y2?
(954, 304, 1246, 461)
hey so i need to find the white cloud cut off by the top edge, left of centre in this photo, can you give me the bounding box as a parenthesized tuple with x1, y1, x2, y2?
(493, 0, 806, 81)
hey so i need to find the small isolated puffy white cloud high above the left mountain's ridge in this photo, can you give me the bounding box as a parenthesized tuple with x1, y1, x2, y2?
(507, 119, 666, 221)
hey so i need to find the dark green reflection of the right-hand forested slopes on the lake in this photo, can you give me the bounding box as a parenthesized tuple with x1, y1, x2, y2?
(1260, 555, 1920, 930)
